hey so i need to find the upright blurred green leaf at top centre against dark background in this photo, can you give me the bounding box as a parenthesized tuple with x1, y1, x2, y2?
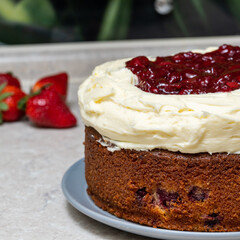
(98, 0, 132, 40)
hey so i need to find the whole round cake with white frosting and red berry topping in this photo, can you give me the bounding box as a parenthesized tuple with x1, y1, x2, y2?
(78, 45, 240, 232)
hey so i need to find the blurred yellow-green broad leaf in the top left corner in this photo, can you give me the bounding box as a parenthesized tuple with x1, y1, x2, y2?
(0, 0, 57, 28)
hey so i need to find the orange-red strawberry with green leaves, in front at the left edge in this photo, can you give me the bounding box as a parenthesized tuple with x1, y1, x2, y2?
(0, 83, 26, 123)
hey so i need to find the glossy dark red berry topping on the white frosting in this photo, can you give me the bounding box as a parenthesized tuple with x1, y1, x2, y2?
(126, 45, 240, 95)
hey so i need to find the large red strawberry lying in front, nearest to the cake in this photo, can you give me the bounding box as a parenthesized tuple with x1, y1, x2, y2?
(26, 88, 77, 128)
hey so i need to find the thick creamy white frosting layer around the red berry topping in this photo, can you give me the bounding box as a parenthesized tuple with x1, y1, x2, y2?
(78, 48, 240, 153)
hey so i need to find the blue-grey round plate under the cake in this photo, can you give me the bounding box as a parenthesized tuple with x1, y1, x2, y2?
(62, 158, 240, 240)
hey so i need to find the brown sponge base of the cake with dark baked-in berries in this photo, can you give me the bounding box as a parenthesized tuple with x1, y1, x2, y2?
(85, 127, 240, 231)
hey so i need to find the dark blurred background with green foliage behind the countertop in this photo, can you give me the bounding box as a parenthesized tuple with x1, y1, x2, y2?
(0, 0, 240, 44)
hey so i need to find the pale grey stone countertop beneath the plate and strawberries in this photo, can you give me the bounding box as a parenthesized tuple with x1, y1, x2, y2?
(0, 36, 240, 240)
